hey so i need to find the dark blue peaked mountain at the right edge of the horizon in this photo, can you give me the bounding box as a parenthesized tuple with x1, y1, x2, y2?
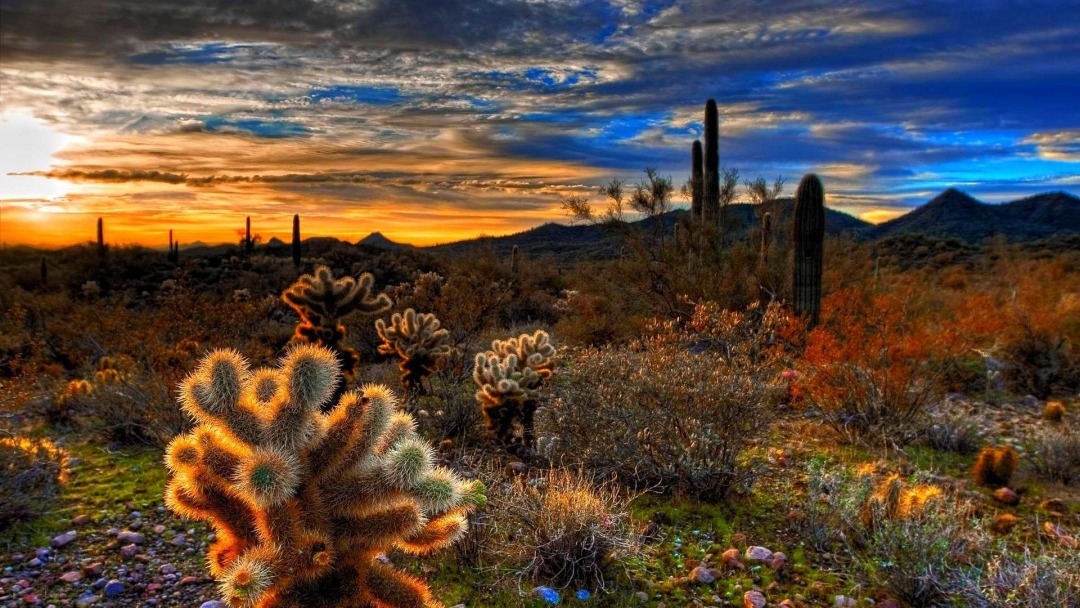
(869, 188, 1080, 242)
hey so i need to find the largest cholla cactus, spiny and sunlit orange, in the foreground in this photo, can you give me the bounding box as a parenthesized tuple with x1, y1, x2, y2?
(165, 344, 486, 608)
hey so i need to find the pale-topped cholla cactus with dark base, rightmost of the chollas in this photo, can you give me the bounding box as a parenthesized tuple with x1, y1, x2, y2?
(473, 329, 555, 448)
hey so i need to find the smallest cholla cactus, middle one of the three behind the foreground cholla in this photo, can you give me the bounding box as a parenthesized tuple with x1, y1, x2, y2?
(375, 308, 453, 393)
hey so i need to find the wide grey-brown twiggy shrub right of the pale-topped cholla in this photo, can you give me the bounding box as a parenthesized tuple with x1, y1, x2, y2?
(538, 303, 788, 500)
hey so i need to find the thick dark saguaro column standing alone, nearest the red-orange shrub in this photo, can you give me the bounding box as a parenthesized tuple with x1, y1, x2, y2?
(792, 173, 825, 327)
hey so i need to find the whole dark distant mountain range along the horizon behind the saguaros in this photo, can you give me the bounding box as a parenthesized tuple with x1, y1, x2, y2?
(357, 188, 1080, 258)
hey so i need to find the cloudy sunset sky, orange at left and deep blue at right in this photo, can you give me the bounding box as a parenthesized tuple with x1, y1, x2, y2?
(0, 0, 1080, 246)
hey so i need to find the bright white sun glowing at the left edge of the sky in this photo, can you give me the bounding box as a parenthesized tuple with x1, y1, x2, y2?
(0, 111, 78, 201)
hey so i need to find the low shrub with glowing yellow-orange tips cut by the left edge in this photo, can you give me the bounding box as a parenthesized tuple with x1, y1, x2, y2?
(0, 436, 67, 530)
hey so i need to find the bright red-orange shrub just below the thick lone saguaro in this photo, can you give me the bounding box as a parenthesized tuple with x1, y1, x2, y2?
(800, 286, 970, 445)
